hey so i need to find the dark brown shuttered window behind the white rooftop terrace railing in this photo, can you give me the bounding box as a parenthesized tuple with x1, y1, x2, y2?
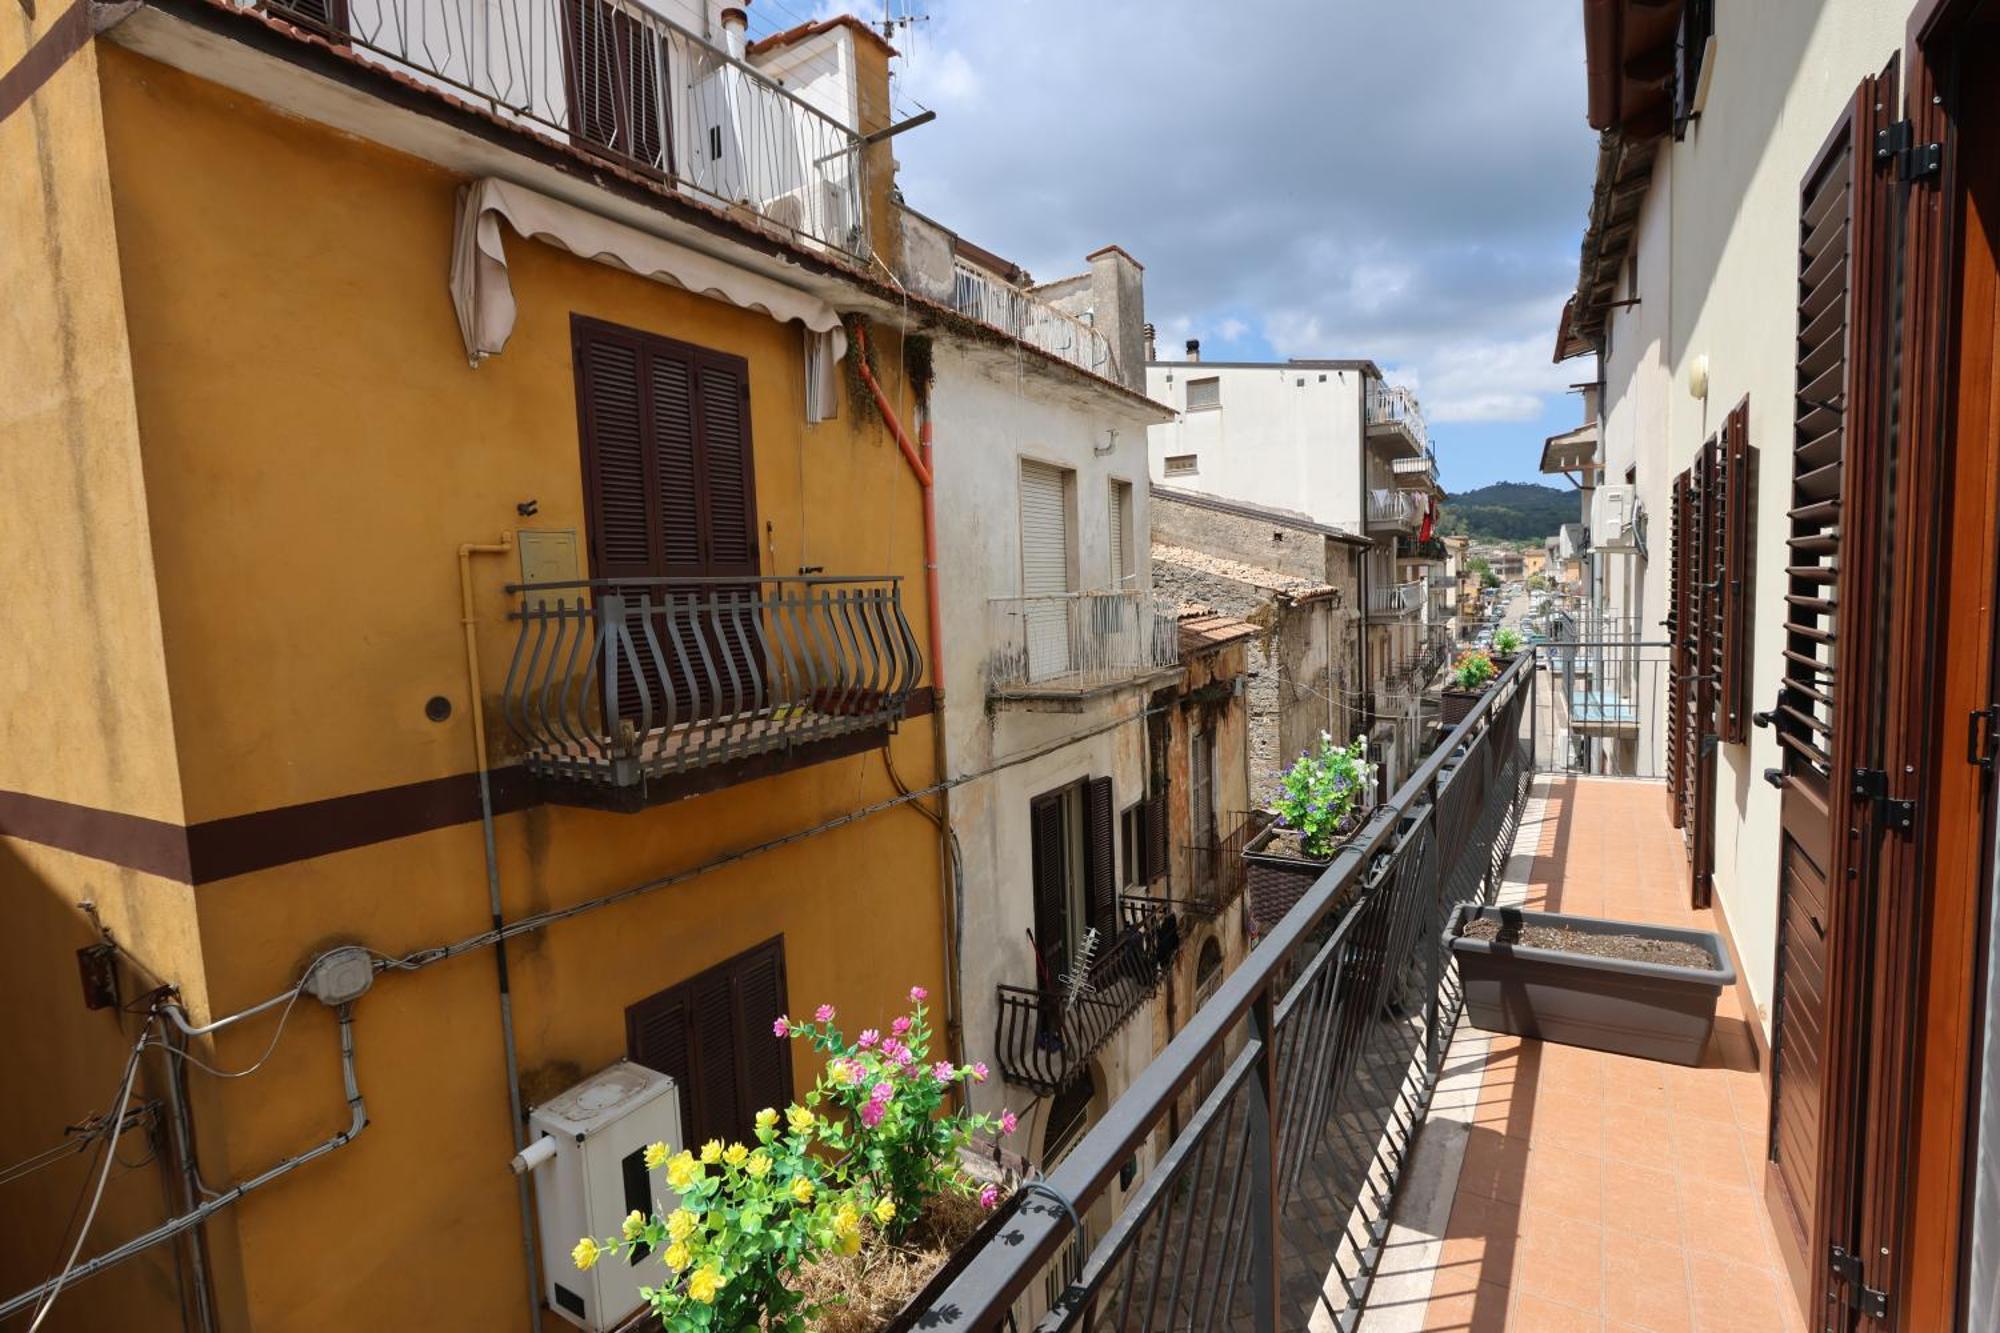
(564, 0, 674, 172)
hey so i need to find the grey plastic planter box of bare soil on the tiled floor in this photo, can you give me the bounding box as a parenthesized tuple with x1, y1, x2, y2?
(1444, 903, 1736, 1065)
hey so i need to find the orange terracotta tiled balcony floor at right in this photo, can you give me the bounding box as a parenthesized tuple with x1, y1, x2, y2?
(1420, 779, 1802, 1333)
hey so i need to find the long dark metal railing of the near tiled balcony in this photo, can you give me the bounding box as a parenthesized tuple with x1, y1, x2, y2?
(918, 656, 1534, 1331)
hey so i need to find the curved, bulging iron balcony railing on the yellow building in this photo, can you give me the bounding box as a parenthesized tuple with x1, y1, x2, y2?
(504, 576, 922, 787)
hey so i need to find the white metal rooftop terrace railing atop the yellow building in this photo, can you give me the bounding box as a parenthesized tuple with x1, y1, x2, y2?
(260, 0, 868, 256)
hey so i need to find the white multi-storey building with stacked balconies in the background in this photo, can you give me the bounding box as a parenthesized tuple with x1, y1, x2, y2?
(1146, 340, 1450, 791)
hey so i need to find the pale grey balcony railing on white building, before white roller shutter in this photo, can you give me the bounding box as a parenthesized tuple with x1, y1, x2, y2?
(986, 590, 1180, 699)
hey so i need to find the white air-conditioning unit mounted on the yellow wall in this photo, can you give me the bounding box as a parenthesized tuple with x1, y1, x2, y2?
(528, 1061, 684, 1333)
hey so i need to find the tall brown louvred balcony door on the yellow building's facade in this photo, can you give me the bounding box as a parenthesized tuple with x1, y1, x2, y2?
(572, 316, 770, 739)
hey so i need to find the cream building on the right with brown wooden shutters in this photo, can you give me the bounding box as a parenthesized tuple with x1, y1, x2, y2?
(1550, 0, 2000, 1329)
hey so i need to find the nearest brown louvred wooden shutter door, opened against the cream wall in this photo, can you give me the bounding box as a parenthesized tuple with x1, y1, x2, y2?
(1760, 64, 1896, 1304)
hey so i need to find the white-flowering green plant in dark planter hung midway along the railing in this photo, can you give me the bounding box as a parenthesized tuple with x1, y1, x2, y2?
(1244, 731, 1376, 931)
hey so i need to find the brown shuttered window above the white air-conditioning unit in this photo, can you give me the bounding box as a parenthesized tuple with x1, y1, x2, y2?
(626, 937, 792, 1143)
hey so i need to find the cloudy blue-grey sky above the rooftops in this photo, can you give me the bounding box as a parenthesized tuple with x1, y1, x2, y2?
(752, 0, 1594, 490)
